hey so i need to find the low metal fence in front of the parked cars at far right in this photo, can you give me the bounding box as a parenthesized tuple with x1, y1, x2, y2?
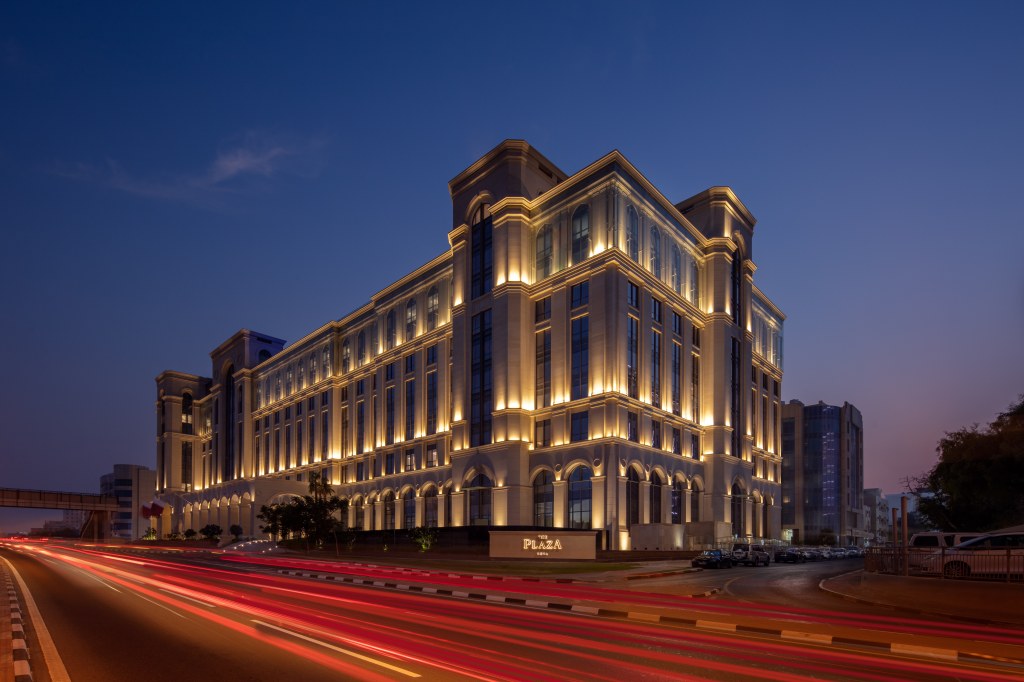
(864, 547, 1024, 583)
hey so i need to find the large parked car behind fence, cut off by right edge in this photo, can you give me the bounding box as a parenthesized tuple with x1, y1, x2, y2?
(922, 532, 1024, 580)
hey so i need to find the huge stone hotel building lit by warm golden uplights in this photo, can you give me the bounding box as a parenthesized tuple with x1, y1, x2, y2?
(157, 140, 784, 549)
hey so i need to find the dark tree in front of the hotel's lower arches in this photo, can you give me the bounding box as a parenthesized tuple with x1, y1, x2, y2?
(257, 472, 348, 547)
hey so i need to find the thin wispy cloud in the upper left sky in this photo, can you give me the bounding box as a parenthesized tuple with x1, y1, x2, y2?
(52, 132, 328, 204)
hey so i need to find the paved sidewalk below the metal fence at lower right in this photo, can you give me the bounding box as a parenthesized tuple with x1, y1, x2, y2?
(819, 570, 1024, 628)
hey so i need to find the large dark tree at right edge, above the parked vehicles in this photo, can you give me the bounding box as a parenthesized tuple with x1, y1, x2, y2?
(911, 395, 1024, 531)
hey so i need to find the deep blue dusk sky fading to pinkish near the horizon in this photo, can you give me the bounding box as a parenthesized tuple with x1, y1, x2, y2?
(0, 2, 1024, 529)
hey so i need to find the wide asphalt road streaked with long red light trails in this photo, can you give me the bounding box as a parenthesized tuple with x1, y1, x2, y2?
(3, 545, 1024, 682)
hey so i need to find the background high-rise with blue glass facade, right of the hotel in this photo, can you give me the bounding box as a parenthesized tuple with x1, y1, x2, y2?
(782, 400, 868, 545)
